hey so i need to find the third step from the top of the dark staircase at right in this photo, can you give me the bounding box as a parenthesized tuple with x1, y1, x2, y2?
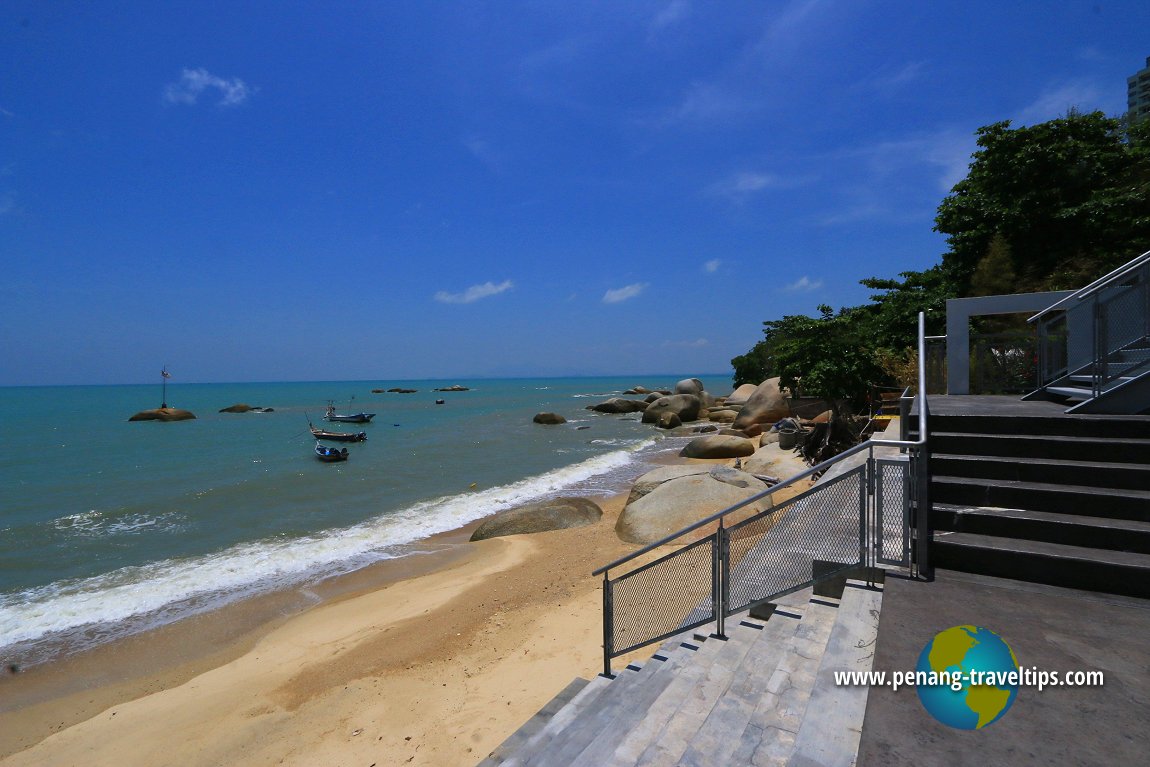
(930, 453, 1150, 490)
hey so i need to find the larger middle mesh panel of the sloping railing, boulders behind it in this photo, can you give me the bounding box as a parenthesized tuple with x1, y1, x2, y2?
(723, 465, 866, 615)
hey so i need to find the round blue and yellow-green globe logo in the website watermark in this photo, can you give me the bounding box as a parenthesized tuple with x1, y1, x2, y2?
(914, 626, 1019, 730)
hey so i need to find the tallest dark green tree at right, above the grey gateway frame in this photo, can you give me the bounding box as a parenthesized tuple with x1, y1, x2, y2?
(935, 112, 1150, 296)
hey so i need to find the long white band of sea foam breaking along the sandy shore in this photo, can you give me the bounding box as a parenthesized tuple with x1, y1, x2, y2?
(0, 438, 657, 664)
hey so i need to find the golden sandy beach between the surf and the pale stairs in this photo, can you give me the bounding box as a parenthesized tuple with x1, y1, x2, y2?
(0, 443, 803, 767)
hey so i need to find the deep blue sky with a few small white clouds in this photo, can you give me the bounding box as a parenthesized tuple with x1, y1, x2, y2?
(0, 0, 1150, 385)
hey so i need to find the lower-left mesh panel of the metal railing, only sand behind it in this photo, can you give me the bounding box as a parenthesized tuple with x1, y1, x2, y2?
(607, 534, 718, 655)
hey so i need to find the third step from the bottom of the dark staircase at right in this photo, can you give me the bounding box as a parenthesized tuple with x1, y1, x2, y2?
(930, 476, 1150, 522)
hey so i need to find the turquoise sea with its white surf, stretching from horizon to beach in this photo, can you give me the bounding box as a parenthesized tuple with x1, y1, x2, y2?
(0, 376, 729, 665)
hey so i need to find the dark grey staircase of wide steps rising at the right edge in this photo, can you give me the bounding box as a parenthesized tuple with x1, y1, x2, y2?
(915, 407, 1150, 598)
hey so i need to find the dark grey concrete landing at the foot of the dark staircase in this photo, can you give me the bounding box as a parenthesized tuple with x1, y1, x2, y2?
(857, 570, 1150, 767)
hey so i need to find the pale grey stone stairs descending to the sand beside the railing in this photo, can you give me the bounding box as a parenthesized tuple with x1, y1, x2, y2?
(481, 581, 882, 767)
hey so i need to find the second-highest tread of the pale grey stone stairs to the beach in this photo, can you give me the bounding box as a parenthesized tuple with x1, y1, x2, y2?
(728, 599, 838, 765)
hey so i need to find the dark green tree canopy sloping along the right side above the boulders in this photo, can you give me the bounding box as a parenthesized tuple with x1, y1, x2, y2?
(731, 110, 1150, 399)
